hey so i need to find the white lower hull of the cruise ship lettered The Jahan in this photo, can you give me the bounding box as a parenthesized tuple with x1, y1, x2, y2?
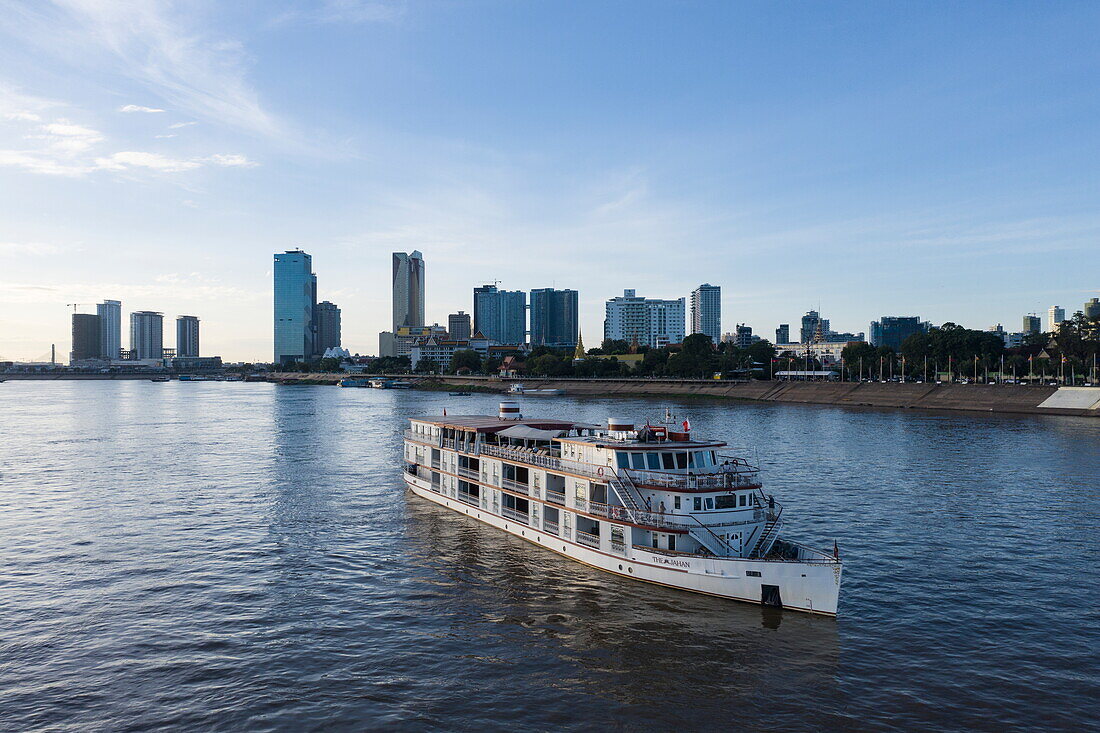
(403, 473, 842, 616)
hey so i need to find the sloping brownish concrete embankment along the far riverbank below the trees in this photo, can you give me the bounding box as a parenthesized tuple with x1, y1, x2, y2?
(270, 374, 1100, 417)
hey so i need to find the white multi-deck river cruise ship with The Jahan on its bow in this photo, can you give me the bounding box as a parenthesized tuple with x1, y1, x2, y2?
(404, 402, 842, 615)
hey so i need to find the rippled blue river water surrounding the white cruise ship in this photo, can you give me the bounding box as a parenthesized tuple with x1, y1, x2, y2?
(0, 382, 1100, 730)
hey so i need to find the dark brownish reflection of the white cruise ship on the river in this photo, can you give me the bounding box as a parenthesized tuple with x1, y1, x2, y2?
(407, 493, 838, 726)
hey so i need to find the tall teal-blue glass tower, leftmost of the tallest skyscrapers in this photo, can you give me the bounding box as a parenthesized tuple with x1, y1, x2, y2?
(273, 250, 317, 364)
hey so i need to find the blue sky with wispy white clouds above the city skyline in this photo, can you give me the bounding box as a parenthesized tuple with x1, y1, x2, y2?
(0, 0, 1100, 359)
